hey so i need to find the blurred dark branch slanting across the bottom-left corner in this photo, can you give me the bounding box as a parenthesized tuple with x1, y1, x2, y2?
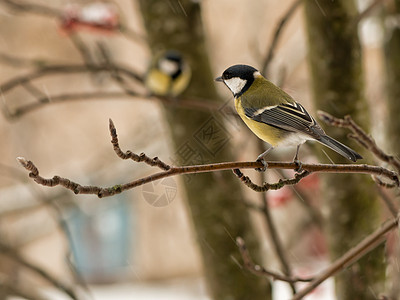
(0, 241, 78, 300)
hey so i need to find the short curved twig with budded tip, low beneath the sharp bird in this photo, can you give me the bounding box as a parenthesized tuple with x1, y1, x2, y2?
(236, 237, 313, 284)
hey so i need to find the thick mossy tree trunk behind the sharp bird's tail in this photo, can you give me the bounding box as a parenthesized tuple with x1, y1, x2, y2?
(304, 0, 385, 300)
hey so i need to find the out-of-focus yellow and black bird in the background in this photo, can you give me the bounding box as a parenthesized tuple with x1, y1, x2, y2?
(145, 50, 191, 97)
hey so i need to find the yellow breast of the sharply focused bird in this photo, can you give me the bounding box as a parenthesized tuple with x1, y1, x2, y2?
(235, 97, 286, 147)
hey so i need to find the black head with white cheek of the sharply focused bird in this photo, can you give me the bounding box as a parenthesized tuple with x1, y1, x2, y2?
(215, 65, 259, 97)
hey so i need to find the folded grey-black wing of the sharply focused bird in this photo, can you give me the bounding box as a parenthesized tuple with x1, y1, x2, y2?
(243, 102, 325, 139)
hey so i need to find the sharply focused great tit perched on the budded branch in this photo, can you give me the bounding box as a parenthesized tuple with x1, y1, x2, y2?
(215, 65, 362, 165)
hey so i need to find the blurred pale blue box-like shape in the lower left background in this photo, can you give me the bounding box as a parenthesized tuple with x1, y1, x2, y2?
(66, 195, 134, 283)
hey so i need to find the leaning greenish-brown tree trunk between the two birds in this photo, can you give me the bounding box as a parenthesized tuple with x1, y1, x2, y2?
(140, 0, 271, 300)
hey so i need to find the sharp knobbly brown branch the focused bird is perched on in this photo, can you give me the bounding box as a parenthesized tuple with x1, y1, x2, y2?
(17, 120, 399, 197)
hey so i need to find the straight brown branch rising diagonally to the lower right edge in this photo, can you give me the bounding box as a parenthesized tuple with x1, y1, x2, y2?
(292, 217, 399, 300)
